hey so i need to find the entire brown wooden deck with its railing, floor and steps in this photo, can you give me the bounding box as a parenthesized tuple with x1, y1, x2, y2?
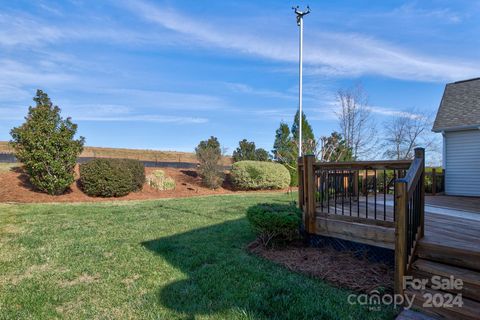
(298, 154, 480, 320)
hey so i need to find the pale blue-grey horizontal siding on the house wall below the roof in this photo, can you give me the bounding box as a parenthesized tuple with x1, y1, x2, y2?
(444, 130, 480, 196)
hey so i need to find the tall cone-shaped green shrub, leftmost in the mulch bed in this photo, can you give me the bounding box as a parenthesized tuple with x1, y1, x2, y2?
(10, 90, 85, 195)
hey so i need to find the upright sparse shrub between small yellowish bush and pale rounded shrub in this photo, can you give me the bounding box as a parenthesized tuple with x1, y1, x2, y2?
(195, 137, 224, 189)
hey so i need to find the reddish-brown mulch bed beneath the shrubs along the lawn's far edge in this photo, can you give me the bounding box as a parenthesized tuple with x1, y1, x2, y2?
(0, 166, 291, 203)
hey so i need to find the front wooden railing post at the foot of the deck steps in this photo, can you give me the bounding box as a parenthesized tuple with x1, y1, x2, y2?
(394, 179, 408, 294)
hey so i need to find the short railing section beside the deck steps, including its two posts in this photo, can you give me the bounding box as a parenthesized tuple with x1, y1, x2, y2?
(395, 148, 425, 294)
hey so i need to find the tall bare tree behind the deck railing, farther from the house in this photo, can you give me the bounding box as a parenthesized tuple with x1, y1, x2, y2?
(336, 85, 378, 159)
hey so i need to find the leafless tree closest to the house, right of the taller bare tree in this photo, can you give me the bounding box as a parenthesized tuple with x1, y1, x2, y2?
(383, 109, 436, 160)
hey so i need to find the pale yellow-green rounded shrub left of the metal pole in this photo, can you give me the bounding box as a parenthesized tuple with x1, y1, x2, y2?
(230, 160, 290, 190)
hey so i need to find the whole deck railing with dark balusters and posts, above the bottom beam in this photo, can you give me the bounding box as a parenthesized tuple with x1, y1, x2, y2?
(298, 148, 425, 293)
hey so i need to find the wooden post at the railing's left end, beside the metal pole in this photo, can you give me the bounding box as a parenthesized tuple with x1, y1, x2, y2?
(303, 154, 316, 233)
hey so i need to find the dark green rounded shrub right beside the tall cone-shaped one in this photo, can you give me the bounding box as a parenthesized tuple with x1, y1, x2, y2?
(80, 159, 145, 197)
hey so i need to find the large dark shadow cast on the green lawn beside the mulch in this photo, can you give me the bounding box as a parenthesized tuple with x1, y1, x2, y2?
(142, 219, 393, 319)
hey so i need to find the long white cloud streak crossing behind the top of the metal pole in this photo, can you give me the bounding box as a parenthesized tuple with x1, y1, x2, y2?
(126, 1, 478, 81)
